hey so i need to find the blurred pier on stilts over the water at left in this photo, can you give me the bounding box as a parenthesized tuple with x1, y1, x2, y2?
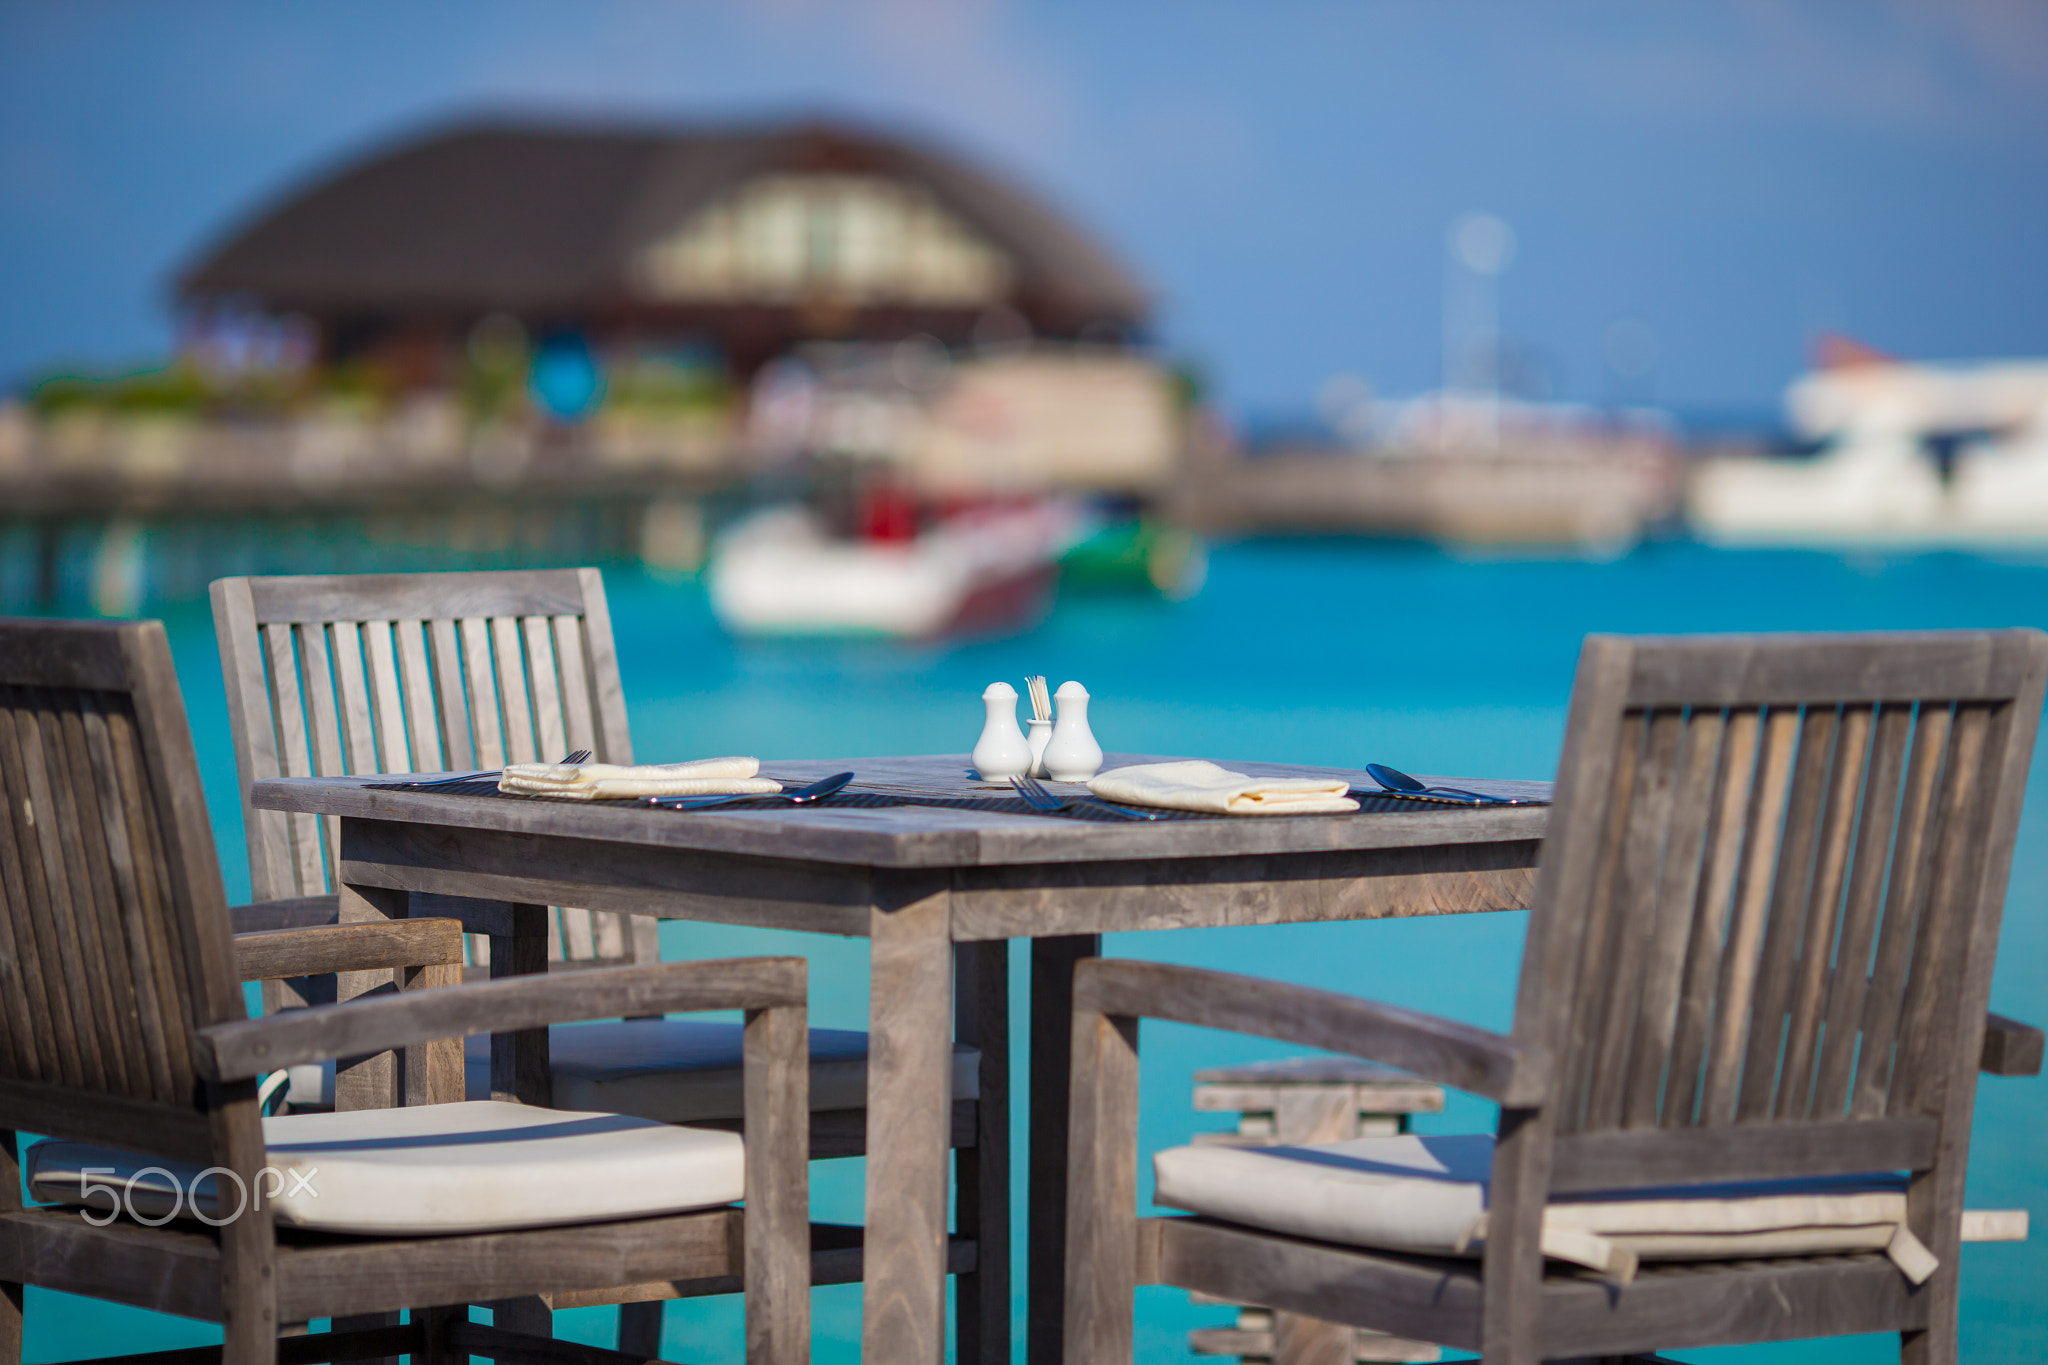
(0, 411, 724, 616)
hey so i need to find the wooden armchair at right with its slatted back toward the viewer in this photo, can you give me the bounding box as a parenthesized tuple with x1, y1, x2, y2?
(1065, 630, 2048, 1365)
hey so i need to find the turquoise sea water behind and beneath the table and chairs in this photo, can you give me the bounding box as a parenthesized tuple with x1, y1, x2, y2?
(27, 540, 2048, 1365)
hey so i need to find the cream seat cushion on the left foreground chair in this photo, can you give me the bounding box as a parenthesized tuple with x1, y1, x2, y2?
(29, 1101, 745, 1236)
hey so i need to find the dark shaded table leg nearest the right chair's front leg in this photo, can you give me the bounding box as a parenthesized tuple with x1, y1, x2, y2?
(1024, 933, 1102, 1365)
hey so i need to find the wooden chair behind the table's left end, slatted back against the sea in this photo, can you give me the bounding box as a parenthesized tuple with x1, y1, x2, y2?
(213, 569, 1010, 1359)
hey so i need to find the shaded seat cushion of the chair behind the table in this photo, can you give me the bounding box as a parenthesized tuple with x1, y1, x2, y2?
(291, 1019, 981, 1124)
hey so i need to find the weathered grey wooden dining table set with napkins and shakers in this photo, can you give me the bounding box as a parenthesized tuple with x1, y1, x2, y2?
(252, 753, 1550, 1365)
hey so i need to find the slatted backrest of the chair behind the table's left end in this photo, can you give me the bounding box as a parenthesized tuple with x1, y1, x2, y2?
(213, 569, 645, 960)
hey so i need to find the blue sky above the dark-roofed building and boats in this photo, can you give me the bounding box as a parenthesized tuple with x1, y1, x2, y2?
(0, 0, 2048, 421)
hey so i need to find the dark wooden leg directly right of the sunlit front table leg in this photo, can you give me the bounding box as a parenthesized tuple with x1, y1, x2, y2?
(952, 939, 1010, 1365)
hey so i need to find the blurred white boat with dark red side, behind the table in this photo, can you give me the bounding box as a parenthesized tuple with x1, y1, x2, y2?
(711, 497, 1090, 639)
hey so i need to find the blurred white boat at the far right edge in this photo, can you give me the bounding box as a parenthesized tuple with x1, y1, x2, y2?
(1688, 342, 2048, 544)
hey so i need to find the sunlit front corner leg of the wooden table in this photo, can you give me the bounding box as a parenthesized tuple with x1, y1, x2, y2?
(860, 872, 952, 1365)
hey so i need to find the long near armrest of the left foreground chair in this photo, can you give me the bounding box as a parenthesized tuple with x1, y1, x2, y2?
(193, 958, 805, 1081)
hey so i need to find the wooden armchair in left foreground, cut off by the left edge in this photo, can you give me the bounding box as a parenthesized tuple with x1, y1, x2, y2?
(0, 622, 809, 1365)
